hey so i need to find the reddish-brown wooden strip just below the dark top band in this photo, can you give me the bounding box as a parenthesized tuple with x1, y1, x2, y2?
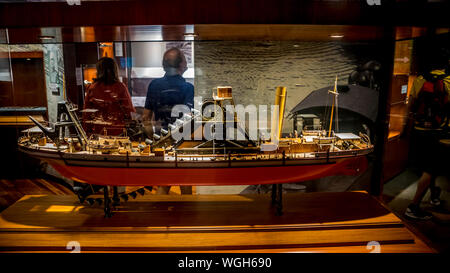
(4, 24, 383, 44)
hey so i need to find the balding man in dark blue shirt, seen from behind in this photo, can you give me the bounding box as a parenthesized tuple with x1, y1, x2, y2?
(142, 48, 194, 194)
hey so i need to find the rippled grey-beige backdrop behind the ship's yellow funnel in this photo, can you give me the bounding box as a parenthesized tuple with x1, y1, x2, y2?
(194, 41, 380, 131)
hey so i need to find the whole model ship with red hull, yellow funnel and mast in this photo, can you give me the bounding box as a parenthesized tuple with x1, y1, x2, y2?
(18, 78, 373, 215)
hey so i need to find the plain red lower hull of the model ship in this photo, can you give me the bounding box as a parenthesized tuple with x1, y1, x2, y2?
(41, 156, 367, 186)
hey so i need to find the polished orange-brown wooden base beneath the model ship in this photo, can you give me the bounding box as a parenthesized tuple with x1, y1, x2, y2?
(0, 192, 432, 253)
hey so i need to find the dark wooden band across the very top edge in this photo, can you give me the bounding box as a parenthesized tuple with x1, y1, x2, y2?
(0, 0, 449, 27)
